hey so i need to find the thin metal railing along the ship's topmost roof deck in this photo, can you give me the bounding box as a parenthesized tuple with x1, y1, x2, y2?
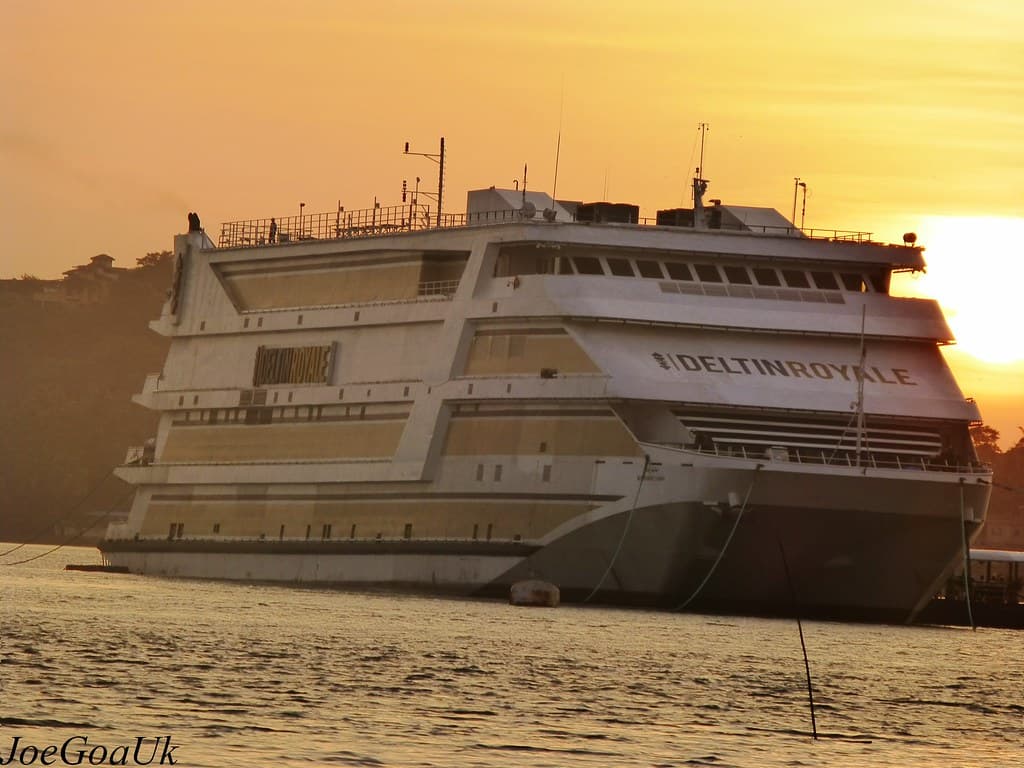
(217, 205, 872, 248)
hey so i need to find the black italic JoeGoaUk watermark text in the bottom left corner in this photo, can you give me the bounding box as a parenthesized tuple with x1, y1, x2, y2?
(0, 736, 178, 766)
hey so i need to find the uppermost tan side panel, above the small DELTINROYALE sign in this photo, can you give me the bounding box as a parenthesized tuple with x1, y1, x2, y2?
(225, 261, 420, 310)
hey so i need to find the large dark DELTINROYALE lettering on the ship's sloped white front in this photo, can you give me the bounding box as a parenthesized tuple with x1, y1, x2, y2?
(651, 352, 918, 387)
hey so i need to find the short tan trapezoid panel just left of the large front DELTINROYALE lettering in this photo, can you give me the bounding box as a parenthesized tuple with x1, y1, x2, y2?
(464, 329, 601, 376)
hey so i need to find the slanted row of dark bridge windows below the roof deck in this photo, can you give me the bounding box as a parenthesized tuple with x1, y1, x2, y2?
(558, 256, 886, 293)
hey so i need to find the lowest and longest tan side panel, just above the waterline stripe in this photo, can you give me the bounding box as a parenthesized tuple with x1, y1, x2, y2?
(141, 497, 596, 541)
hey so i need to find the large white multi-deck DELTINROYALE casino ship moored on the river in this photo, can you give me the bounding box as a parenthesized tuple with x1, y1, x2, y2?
(100, 171, 990, 622)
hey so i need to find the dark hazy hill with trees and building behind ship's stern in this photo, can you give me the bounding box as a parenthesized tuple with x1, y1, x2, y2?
(0, 253, 171, 541)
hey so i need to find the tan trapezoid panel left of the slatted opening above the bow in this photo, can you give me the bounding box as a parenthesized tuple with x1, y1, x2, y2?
(444, 414, 641, 456)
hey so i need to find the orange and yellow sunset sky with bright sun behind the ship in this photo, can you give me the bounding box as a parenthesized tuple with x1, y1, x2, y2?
(0, 0, 1024, 447)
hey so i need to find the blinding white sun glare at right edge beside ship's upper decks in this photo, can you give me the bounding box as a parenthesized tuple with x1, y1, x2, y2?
(894, 216, 1024, 364)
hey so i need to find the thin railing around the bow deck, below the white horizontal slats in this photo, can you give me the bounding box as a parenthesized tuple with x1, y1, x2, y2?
(691, 442, 990, 474)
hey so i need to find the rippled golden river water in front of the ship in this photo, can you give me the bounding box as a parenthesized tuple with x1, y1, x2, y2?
(0, 546, 1024, 768)
